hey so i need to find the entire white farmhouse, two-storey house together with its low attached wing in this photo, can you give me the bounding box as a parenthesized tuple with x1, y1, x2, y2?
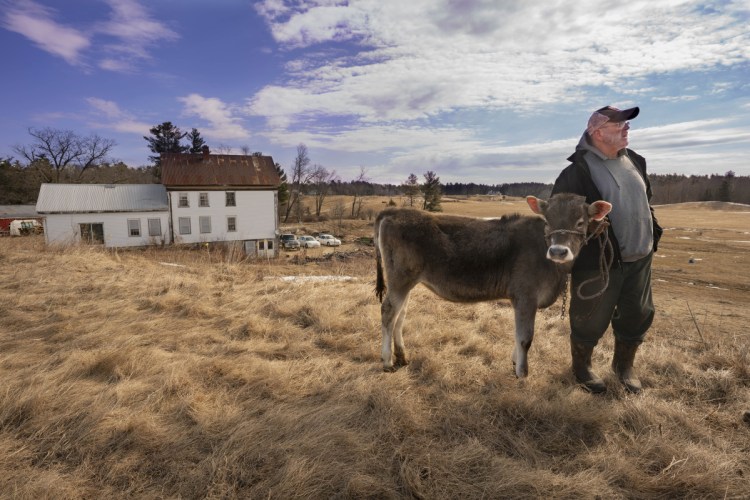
(36, 148, 281, 257)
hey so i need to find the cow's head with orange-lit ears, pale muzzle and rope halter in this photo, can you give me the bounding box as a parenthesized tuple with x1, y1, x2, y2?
(526, 193, 612, 264)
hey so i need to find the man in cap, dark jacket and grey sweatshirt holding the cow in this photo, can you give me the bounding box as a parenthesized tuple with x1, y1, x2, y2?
(552, 106, 662, 393)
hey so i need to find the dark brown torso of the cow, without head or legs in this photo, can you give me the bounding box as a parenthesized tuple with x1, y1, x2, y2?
(375, 209, 557, 302)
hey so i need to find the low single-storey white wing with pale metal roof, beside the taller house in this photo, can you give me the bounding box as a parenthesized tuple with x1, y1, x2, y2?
(36, 184, 171, 247)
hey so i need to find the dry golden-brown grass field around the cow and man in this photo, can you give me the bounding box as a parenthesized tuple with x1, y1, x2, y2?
(0, 199, 750, 499)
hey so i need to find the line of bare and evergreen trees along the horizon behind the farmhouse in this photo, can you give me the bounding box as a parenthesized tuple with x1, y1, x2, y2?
(0, 128, 750, 210)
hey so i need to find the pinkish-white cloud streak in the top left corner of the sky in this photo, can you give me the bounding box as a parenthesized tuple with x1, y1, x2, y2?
(2, 0, 91, 65)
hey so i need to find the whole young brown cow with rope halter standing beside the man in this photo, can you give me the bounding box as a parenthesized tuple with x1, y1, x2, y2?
(374, 193, 612, 377)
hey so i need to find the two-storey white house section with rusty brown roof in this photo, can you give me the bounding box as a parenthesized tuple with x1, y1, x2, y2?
(161, 147, 281, 257)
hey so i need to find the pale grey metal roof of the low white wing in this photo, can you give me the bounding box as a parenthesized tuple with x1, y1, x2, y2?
(36, 184, 169, 214)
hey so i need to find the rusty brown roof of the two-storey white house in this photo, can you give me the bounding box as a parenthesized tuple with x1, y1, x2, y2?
(161, 151, 281, 189)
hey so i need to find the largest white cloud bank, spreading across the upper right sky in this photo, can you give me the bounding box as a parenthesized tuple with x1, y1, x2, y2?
(249, 0, 750, 127)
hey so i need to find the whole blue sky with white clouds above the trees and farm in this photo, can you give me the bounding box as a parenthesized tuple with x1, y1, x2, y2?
(0, 0, 750, 184)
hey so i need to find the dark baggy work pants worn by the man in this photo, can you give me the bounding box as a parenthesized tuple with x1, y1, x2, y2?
(570, 253, 654, 346)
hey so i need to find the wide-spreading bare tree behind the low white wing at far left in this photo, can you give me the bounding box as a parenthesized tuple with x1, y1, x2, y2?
(13, 127, 116, 182)
